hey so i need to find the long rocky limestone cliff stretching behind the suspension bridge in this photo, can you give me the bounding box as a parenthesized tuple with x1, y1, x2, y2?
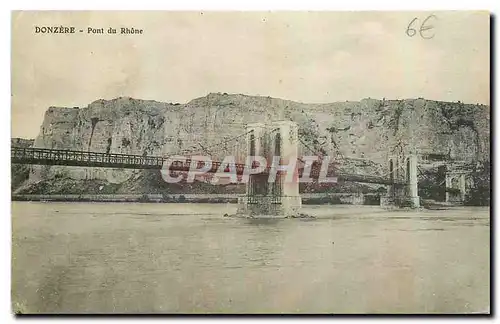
(13, 93, 490, 193)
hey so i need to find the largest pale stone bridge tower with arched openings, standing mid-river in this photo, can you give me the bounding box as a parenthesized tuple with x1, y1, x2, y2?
(238, 121, 302, 217)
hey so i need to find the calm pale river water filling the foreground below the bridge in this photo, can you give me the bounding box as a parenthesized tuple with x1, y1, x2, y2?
(12, 202, 490, 313)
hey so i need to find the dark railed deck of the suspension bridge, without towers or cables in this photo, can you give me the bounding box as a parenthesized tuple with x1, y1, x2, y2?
(11, 147, 392, 185)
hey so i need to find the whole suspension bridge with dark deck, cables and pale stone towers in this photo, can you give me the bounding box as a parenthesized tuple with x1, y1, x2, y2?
(11, 121, 474, 214)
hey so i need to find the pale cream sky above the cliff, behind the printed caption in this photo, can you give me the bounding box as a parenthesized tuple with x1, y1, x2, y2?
(12, 11, 490, 138)
